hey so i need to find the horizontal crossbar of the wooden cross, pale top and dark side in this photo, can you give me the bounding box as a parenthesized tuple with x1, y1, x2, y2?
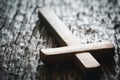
(40, 42, 115, 63)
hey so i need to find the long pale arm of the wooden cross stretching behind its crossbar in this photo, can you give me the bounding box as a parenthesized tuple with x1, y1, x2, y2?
(38, 7, 80, 46)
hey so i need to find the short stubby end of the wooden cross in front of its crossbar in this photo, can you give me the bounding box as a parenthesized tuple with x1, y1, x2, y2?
(74, 52, 100, 74)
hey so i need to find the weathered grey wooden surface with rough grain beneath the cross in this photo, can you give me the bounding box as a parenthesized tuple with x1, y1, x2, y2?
(0, 0, 120, 80)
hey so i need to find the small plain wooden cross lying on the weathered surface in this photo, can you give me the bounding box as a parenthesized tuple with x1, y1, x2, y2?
(39, 7, 114, 73)
